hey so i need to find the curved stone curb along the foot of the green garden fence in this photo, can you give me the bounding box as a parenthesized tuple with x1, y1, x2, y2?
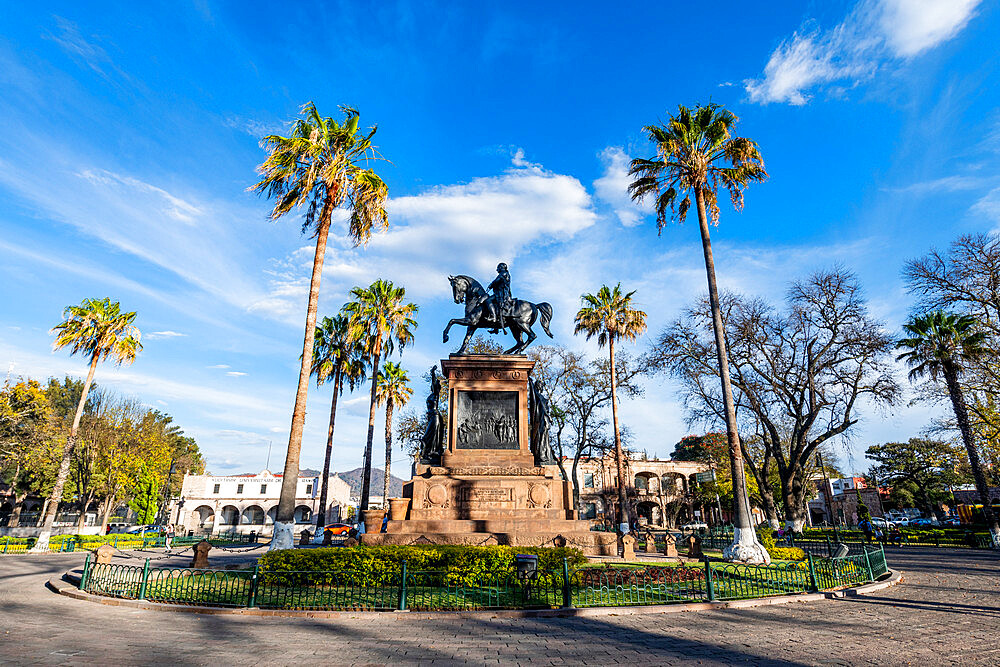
(46, 570, 903, 619)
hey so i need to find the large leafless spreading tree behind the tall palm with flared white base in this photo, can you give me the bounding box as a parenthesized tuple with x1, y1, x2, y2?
(651, 269, 900, 530)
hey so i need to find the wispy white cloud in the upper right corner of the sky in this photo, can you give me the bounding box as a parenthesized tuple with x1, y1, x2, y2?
(743, 0, 980, 105)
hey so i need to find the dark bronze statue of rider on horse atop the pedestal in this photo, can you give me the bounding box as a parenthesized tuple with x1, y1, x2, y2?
(444, 263, 552, 354)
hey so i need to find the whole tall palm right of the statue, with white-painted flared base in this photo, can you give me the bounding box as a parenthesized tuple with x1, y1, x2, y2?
(628, 104, 771, 563)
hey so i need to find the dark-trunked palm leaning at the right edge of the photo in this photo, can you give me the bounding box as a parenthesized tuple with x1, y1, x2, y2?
(896, 310, 1000, 549)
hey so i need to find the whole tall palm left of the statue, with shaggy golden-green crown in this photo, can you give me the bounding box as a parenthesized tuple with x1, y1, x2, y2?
(250, 102, 388, 549)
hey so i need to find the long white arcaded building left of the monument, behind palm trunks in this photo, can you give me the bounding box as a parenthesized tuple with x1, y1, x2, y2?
(169, 470, 351, 535)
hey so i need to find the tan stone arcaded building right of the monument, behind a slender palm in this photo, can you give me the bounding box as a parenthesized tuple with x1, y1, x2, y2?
(565, 456, 711, 527)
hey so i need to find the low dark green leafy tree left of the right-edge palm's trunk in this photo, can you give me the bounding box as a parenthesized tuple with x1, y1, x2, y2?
(865, 438, 960, 518)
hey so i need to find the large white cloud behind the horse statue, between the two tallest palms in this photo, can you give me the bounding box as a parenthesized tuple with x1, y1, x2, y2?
(251, 152, 597, 318)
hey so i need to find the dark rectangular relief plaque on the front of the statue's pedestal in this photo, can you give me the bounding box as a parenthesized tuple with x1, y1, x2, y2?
(455, 391, 520, 449)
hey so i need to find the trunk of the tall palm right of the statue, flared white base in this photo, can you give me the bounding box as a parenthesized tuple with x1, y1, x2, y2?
(694, 187, 771, 563)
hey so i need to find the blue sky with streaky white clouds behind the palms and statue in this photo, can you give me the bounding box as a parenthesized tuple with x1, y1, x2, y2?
(0, 0, 1000, 480)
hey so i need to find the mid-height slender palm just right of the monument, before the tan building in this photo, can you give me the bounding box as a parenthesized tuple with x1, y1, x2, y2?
(573, 283, 646, 532)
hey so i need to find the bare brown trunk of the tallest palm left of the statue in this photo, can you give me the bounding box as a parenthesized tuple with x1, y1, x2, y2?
(270, 211, 333, 550)
